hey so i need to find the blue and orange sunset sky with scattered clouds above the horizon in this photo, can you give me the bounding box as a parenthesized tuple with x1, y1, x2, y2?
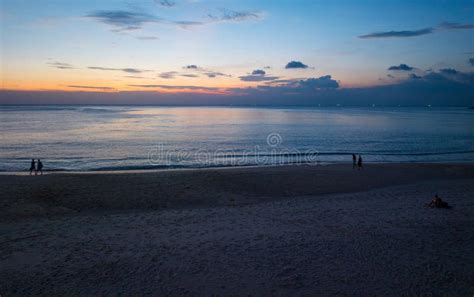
(0, 0, 474, 105)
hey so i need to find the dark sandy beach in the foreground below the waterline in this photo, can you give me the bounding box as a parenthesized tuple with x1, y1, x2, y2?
(0, 164, 474, 296)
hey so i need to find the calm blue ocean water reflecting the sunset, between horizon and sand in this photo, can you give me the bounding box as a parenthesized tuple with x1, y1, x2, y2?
(0, 105, 474, 171)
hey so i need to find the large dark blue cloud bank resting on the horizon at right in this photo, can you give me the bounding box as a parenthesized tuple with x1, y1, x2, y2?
(229, 72, 474, 106)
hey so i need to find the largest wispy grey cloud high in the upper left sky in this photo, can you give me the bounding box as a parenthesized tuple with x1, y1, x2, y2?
(85, 10, 161, 31)
